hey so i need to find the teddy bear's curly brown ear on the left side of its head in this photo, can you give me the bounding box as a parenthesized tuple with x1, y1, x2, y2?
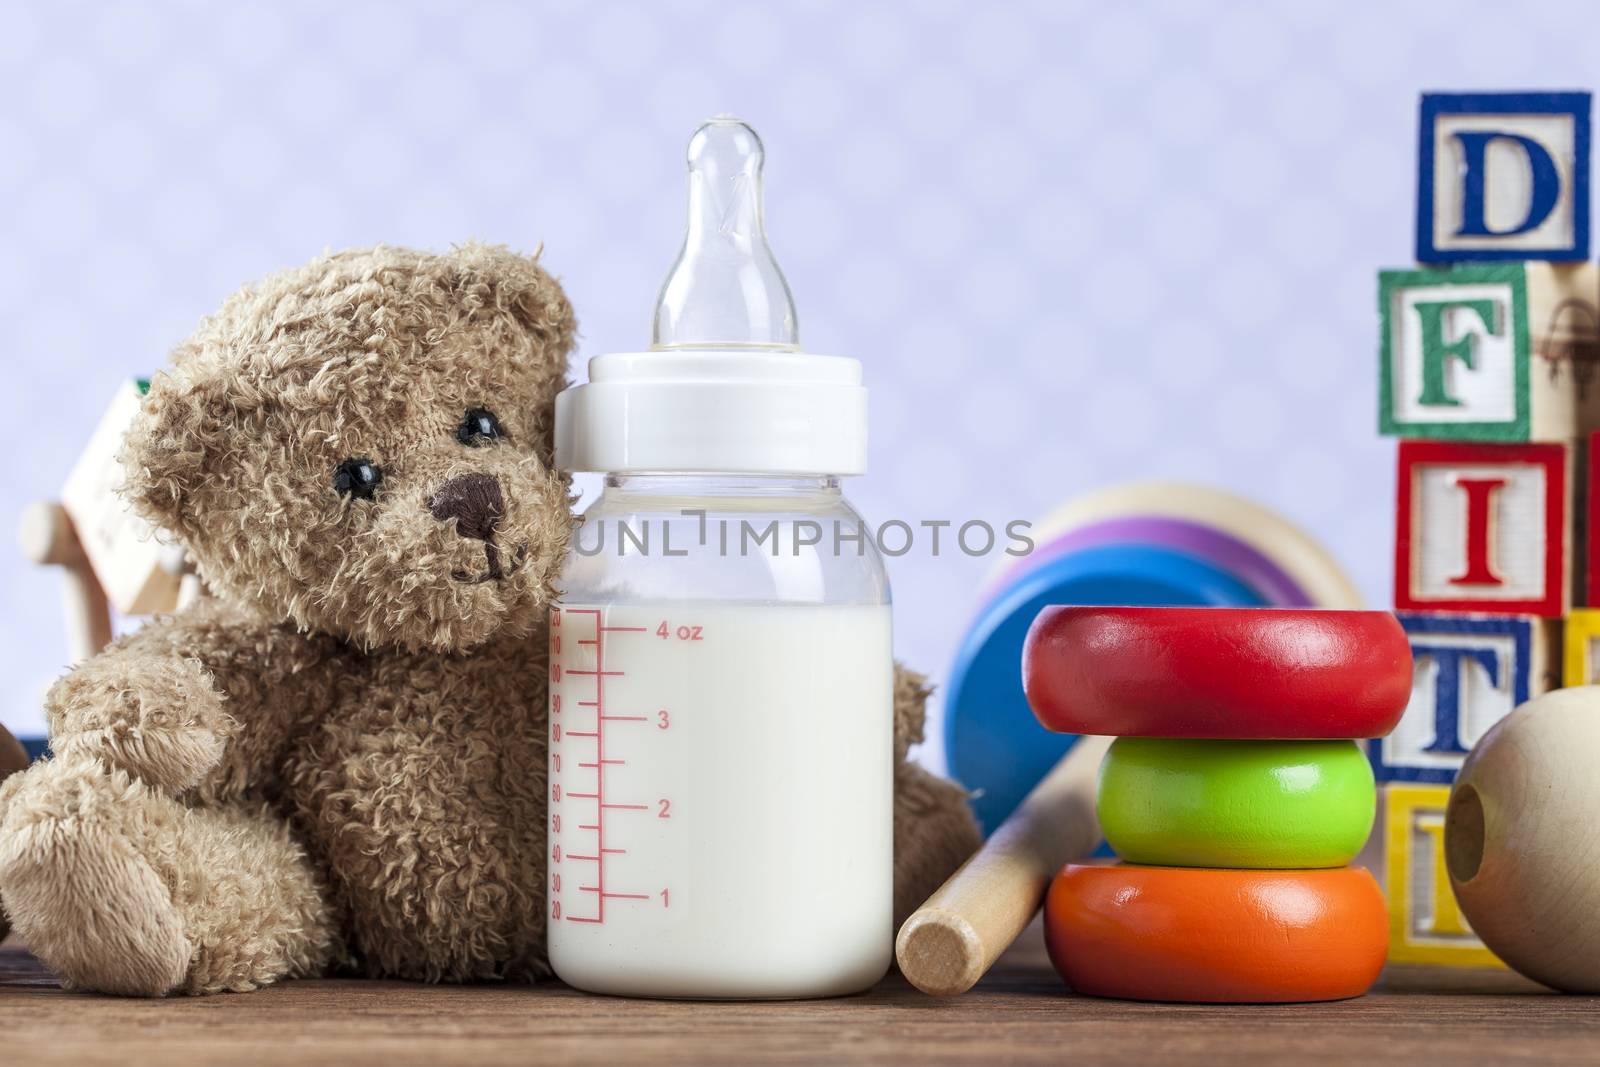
(122, 350, 224, 541)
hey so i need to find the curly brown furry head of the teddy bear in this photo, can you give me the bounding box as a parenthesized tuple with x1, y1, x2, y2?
(125, 245, 576, 651)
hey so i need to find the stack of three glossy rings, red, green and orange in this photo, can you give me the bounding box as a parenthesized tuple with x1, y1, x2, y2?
(1022, 606, 1411, 1003)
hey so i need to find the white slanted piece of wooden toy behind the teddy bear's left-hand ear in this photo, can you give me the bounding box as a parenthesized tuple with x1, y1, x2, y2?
(61, 381, 182, 614)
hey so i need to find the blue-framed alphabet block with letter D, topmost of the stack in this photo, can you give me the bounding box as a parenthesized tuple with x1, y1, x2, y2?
(1416, 93, 1589, 262)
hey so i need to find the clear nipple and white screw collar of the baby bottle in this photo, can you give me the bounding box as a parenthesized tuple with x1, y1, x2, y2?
(555, 115, 867, 475)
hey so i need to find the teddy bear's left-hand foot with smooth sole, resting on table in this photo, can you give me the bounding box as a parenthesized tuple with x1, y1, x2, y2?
(0, 758, 192, 997)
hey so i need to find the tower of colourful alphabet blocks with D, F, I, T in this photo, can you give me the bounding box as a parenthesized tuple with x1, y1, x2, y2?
(1370, 93, 1600, 966)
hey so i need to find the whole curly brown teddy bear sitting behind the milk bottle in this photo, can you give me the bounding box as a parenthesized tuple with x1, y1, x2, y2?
(0, 243, 978, 995)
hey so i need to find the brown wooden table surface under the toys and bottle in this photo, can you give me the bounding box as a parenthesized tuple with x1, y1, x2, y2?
(0, 942, 1600, 1067)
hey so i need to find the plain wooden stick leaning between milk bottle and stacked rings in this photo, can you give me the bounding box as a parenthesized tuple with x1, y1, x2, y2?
(894, 737, 1112, 997)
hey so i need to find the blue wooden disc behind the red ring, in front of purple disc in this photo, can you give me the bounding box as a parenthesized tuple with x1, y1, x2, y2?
(944, 544, 1267, 833)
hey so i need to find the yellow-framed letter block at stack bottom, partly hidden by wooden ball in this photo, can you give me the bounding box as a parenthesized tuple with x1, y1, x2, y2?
(1384, 785, 1504, 966)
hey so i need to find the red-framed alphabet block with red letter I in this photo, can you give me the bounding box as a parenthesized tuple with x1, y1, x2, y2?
(1395, 442, 1571, 617)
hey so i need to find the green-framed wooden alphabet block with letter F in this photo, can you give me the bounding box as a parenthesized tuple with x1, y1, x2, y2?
(1378, 262, 1600, 442)
